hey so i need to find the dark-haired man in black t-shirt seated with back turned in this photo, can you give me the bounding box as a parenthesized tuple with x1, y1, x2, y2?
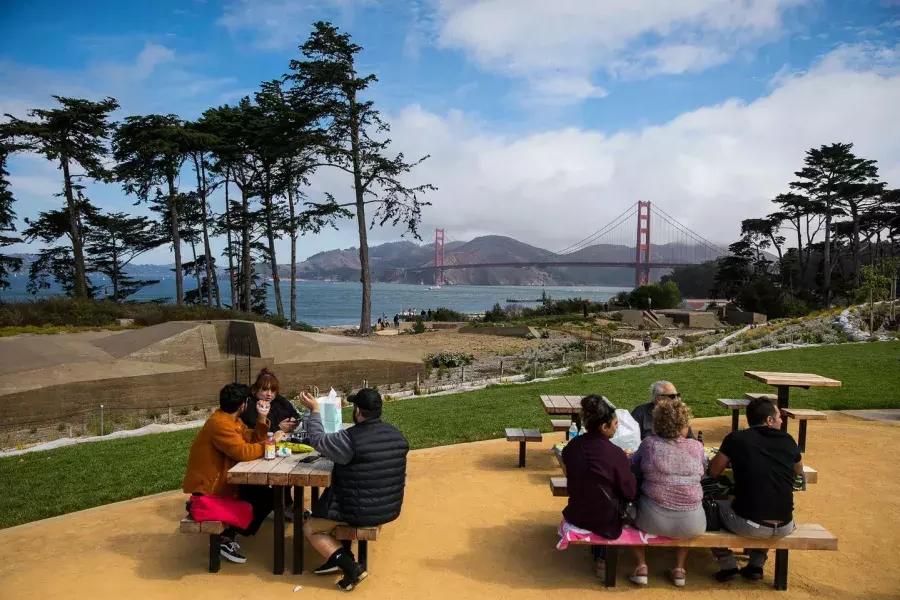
(709, 399, 803, 581)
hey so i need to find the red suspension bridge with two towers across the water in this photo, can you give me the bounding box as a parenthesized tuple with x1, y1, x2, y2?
(404, 201, 728, 286)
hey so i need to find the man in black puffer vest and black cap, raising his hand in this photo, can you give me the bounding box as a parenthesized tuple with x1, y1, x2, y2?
(300, 388, 409, 592)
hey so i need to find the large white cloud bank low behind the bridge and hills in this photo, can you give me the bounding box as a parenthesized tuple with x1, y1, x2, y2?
(378, 47, 900, 250)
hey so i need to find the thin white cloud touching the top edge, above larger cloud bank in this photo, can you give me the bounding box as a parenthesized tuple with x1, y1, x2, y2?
(436, 0, 807, 97)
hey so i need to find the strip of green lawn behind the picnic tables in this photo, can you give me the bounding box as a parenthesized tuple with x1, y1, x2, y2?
(0, 342, 900, 528)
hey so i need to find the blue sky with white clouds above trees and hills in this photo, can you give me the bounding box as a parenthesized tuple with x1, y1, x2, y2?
(0, 0, 900, 262)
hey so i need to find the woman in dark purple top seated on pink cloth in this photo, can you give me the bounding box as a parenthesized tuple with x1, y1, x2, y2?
(562, 395, 637, 576)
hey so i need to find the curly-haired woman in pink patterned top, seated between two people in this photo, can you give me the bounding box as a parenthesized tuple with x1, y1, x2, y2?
(630, 399, 706, 587)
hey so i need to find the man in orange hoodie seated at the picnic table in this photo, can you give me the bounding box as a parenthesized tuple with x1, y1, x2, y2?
(181, 383, 285, 563)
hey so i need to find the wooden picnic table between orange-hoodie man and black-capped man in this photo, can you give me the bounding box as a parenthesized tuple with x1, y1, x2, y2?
(228, 452, 334, 575)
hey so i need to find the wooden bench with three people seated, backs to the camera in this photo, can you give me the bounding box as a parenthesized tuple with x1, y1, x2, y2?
(569, 523, 837, 591)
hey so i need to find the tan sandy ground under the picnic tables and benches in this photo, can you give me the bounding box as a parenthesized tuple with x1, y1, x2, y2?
(0, 413, 900, 600)
